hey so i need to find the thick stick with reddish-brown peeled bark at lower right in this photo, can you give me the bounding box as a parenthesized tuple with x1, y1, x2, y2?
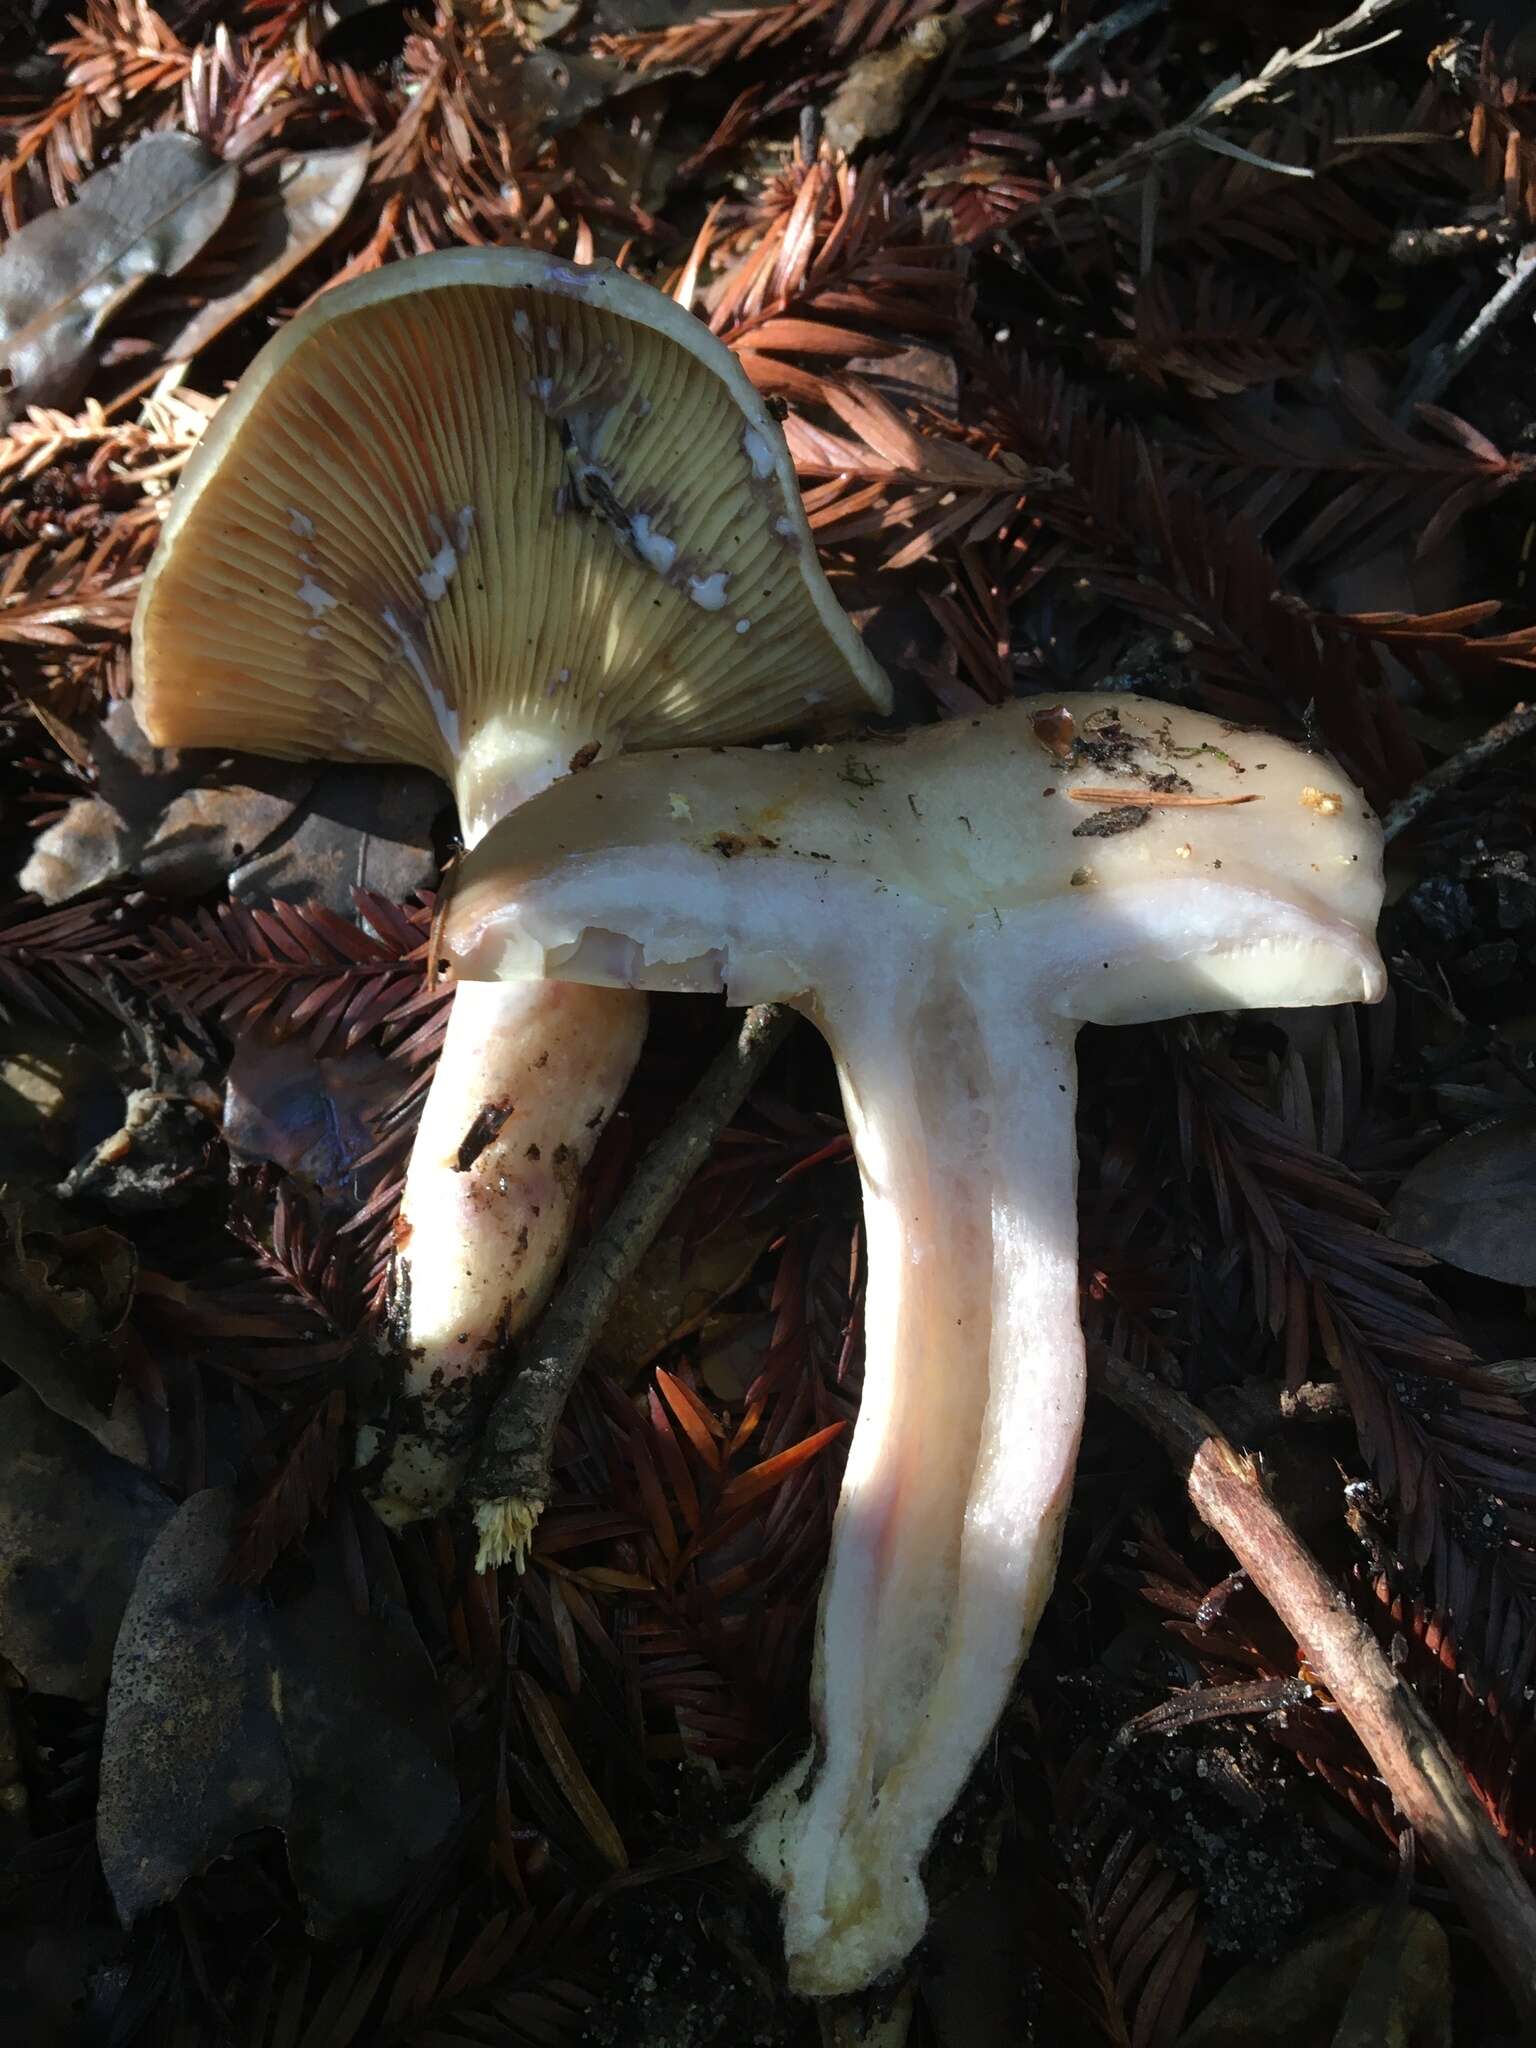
(1094, 1352, 1536, 2025)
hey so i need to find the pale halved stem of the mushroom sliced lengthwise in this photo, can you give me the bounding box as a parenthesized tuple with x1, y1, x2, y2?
(748, 948, 1083, 1995)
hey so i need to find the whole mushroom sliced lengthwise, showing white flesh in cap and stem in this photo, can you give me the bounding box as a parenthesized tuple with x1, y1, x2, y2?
(444, 694, 1384, 1995)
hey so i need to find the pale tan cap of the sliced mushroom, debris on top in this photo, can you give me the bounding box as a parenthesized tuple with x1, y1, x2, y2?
(444, 696, 1382, 1024)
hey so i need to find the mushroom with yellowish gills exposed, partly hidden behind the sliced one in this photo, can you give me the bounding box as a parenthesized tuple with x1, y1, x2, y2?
(133, 248, 889, 1559)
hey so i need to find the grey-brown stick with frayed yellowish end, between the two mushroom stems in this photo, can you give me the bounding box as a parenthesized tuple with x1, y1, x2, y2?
(467, 1004, 795, 1571)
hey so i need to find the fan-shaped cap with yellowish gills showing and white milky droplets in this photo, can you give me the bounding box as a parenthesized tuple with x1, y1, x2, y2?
(133, 250, 889, 838)
